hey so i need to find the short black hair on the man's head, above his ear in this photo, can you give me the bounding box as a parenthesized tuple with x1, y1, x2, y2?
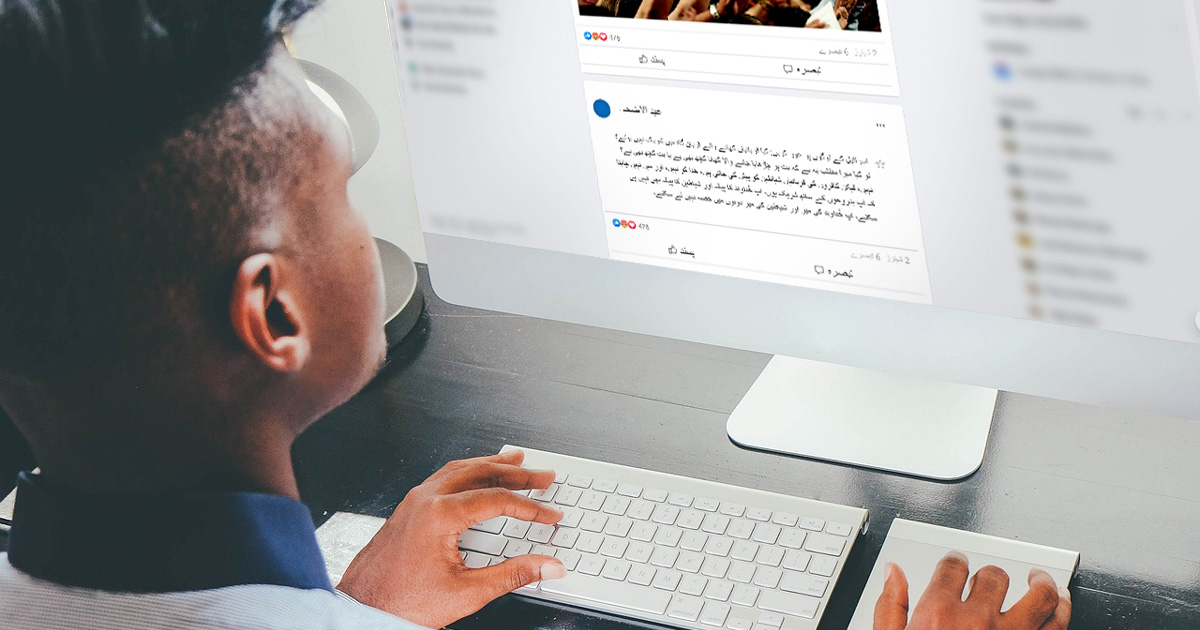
(0, 0, 319, 379)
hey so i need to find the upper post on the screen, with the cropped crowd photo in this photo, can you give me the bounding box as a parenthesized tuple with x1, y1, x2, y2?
(565, 0, 900, 96)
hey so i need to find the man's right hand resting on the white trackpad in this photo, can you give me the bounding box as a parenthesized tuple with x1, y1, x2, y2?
(875, 552, 1070, 630)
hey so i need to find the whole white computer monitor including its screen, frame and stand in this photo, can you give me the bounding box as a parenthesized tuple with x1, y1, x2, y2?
(392, 0, 1200, 479)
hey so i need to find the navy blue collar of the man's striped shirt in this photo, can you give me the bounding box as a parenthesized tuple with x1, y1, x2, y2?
(8, 473, 332, 593)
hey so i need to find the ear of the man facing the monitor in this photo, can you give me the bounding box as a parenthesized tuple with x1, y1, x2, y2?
(229, 253, 312, 372)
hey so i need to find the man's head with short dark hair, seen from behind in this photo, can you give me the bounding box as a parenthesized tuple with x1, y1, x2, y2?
(0, 0, 384, 489)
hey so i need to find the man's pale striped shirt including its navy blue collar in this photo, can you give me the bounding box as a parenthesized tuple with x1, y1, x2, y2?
(0, 474, 429, 630)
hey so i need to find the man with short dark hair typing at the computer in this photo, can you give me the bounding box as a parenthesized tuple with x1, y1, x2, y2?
(0, 0, 1057, 630)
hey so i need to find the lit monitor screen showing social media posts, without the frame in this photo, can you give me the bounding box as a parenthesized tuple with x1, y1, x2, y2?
(394, 0, 1200, 342)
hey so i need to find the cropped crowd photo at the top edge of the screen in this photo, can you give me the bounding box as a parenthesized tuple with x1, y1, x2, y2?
(576, 0, 883, 32)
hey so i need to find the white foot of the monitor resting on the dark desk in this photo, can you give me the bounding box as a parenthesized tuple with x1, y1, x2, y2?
(727, 356, 996, 481)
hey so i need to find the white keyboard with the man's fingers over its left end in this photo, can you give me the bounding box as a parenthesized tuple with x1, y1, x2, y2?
(458, 446, 868, 630)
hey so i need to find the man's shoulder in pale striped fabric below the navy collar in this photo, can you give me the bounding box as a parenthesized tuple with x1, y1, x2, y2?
(0, 554, 419, 630)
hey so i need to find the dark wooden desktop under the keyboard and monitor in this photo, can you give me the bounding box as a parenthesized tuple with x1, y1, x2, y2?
(2, 262, 1200, 630)
